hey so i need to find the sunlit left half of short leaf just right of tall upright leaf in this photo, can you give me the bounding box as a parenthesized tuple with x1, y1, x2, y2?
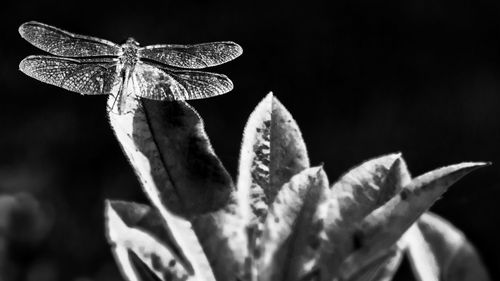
(255, 167, 326, 281)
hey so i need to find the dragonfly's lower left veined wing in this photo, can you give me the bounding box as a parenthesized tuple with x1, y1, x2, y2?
(19, 56, 120, 95)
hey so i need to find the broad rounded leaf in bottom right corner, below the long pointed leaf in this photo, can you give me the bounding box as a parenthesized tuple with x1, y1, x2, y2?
(404, 213, 490, 281)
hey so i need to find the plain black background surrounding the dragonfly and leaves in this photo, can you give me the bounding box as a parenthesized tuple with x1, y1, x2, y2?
(0, 0, 500, 281)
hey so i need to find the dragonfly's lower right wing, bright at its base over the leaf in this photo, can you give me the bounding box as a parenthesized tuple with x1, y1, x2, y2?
(132, 62, 233, 101)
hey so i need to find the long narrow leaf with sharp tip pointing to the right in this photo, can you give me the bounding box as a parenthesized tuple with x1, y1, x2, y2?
(341, 163, 487, 277)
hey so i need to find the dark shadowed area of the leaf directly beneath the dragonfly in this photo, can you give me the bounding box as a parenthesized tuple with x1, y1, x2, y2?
(132, 99, 234, 215)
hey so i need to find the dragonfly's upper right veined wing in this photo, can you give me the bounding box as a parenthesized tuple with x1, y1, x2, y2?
(138, 42, 243, 68)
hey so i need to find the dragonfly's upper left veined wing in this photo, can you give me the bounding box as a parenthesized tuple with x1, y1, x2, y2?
(19, 21, 120, 57)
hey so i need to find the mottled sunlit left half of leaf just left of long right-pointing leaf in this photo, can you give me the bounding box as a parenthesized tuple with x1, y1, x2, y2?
(319, 153, 405, 281)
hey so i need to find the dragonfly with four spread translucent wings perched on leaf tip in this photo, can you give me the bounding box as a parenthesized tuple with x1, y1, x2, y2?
(19, 21, 243, 114)
